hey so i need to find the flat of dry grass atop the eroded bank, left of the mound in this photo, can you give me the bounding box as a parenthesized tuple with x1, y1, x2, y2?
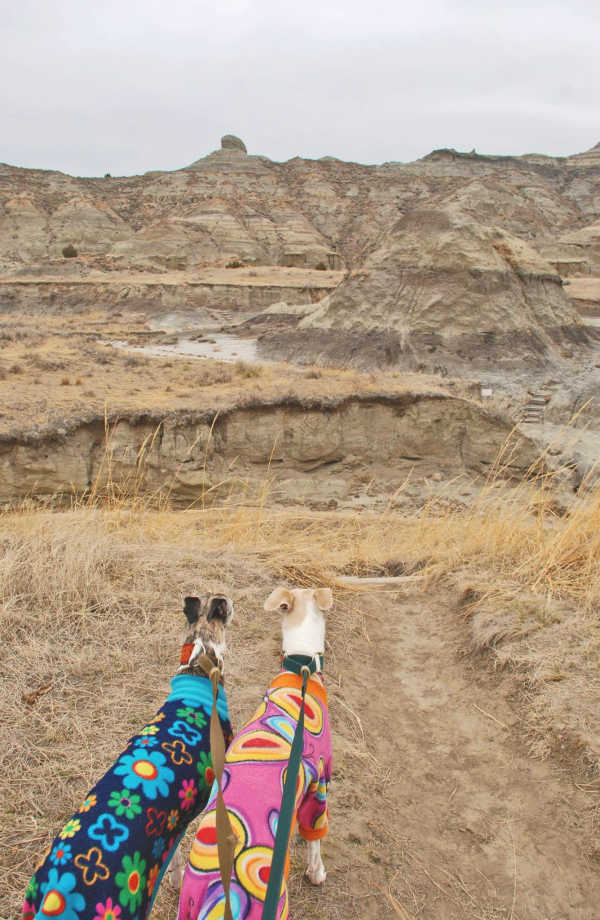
(0, 310, 450, 433)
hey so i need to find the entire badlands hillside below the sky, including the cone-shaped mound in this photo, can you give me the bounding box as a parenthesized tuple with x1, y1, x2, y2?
(0, 137, 600, 369)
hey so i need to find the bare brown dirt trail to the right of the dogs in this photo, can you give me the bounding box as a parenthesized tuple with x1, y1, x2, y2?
(291, 593, 600, 920)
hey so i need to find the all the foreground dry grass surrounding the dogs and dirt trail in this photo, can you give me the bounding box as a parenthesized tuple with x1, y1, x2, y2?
(0, 444, 600, 920)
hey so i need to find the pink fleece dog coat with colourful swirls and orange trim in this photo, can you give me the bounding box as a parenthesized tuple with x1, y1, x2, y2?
(178, 671, 331, 920)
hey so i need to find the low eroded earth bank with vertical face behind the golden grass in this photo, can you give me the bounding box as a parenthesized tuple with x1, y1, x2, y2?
(0, 393, 536, 504)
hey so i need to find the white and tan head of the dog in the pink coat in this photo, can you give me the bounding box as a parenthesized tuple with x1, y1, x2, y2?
(265, 588, 333, 655)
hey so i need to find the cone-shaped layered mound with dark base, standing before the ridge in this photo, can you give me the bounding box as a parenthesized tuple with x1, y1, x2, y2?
(270, 203, 585, 367)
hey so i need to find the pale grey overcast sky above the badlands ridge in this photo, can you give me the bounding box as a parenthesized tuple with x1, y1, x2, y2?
(0, 0, 600, 175)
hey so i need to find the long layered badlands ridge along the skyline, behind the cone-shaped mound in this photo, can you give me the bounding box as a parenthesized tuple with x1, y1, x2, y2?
(0, 142, 600, 272)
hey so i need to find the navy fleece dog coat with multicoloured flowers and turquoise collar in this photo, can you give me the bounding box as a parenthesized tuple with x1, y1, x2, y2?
(23, 674, 232, 920)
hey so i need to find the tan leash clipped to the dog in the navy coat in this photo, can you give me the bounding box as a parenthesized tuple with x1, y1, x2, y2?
(194, 655, 237, 920)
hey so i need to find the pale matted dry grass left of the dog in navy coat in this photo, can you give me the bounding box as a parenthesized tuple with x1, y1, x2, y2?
(0, 507, 370, 918)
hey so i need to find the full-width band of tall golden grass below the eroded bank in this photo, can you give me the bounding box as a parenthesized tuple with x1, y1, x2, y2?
(9, 422, 600, 609)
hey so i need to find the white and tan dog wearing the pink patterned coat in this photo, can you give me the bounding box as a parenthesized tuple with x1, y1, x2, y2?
(178, 587, 333, 920)
